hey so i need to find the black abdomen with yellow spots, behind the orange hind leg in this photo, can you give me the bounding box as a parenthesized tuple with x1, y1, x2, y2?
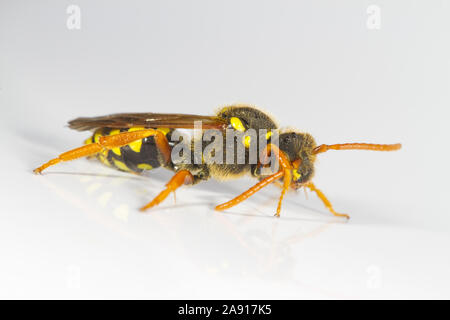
(85, 128, 169, 173)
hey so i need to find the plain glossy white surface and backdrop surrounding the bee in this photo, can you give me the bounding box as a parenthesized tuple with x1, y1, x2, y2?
(0, 1, 450, 298)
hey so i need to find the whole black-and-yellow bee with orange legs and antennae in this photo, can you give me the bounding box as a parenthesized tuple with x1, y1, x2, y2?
(34, 105, 401, 218)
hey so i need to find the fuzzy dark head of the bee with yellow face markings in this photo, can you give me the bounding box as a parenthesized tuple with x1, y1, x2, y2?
(279, 131, 316, 189)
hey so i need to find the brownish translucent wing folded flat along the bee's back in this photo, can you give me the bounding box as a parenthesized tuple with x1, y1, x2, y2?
(69, 113, 227, 131)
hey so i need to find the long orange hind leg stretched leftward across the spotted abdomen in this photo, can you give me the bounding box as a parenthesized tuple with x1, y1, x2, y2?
(34, 129, 170, 174)
